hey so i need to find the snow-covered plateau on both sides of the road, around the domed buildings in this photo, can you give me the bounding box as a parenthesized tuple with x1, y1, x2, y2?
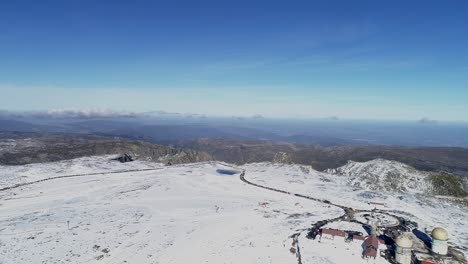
(0, 156, 468, 264)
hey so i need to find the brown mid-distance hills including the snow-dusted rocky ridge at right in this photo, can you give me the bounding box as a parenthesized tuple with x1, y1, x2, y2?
(0, 132, 468, 197)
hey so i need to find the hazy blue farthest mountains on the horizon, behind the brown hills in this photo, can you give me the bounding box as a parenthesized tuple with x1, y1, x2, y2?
(0, 114, 468, 147)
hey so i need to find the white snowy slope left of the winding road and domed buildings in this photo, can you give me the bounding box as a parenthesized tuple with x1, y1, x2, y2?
(0, 159, 342, 264)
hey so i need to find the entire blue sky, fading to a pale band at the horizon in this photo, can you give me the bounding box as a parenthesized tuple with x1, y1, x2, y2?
(0, 0, 468, 121)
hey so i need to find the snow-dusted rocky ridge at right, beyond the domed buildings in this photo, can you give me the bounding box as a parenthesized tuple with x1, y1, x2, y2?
(326, 159, 431, 193)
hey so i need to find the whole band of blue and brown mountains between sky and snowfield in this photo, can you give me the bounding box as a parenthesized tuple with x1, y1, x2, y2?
(0, 112, 468, 183)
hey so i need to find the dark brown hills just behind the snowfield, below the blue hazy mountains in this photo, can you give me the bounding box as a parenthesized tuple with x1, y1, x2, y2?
(0, 132, 468, 175)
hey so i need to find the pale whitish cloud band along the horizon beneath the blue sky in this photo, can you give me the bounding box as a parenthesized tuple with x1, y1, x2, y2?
(0, 86, 468, 121)
